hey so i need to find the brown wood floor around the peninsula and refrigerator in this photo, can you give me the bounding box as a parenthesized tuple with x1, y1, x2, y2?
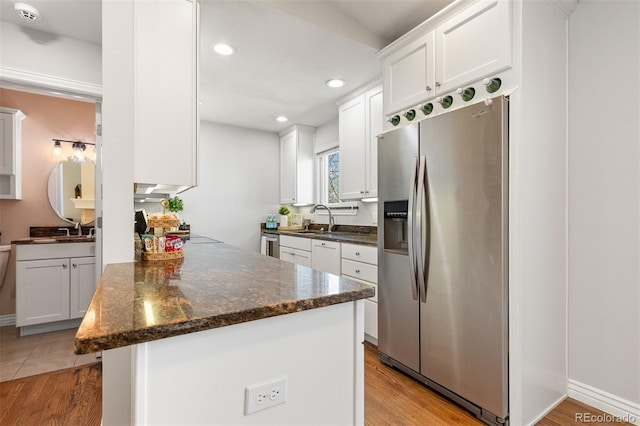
(0, 343, 624, 426)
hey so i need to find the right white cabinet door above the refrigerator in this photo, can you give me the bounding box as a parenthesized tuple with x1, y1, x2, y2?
(436, 0, 511, 93)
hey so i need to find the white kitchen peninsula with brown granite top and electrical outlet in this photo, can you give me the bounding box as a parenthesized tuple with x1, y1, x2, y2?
(76, 243, 374, 425)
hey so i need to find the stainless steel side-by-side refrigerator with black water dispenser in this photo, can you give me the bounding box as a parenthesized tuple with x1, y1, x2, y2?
(378, 96, 509, 424)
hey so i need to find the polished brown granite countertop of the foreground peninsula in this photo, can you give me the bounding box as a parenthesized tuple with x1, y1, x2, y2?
(75, 243, 374, 354)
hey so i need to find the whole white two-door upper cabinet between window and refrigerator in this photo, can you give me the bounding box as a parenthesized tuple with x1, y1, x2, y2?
(338, 83, 384, 200)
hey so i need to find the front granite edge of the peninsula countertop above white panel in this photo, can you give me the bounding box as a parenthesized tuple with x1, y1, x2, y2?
(74, 286, 375, 355)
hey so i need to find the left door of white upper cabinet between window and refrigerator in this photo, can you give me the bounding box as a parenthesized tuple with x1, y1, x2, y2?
(338, 94, 366, 200)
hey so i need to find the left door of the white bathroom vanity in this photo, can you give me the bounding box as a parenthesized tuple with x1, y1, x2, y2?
(16, 259, 69, 327)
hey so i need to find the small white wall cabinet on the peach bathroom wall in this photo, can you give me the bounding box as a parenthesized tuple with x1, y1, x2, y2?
(0, 107, 26, 200)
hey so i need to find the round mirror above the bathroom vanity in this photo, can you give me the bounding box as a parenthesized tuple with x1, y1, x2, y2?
(48, 161, 95, 225)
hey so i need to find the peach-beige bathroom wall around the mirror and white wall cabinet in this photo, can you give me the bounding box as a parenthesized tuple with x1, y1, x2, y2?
(0, 89, 95, 315)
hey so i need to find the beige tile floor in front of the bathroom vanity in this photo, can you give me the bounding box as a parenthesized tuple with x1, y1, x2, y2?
(0, 325, 96, 382)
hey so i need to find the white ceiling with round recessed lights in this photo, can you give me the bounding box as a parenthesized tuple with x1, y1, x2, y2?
(0, 0, 452, 132)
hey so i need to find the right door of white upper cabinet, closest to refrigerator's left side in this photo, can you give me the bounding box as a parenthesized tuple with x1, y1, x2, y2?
(364, 86, 384, 197)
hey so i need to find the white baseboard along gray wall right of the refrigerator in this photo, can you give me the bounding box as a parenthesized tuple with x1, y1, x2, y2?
(568, 379, 640, 425)
